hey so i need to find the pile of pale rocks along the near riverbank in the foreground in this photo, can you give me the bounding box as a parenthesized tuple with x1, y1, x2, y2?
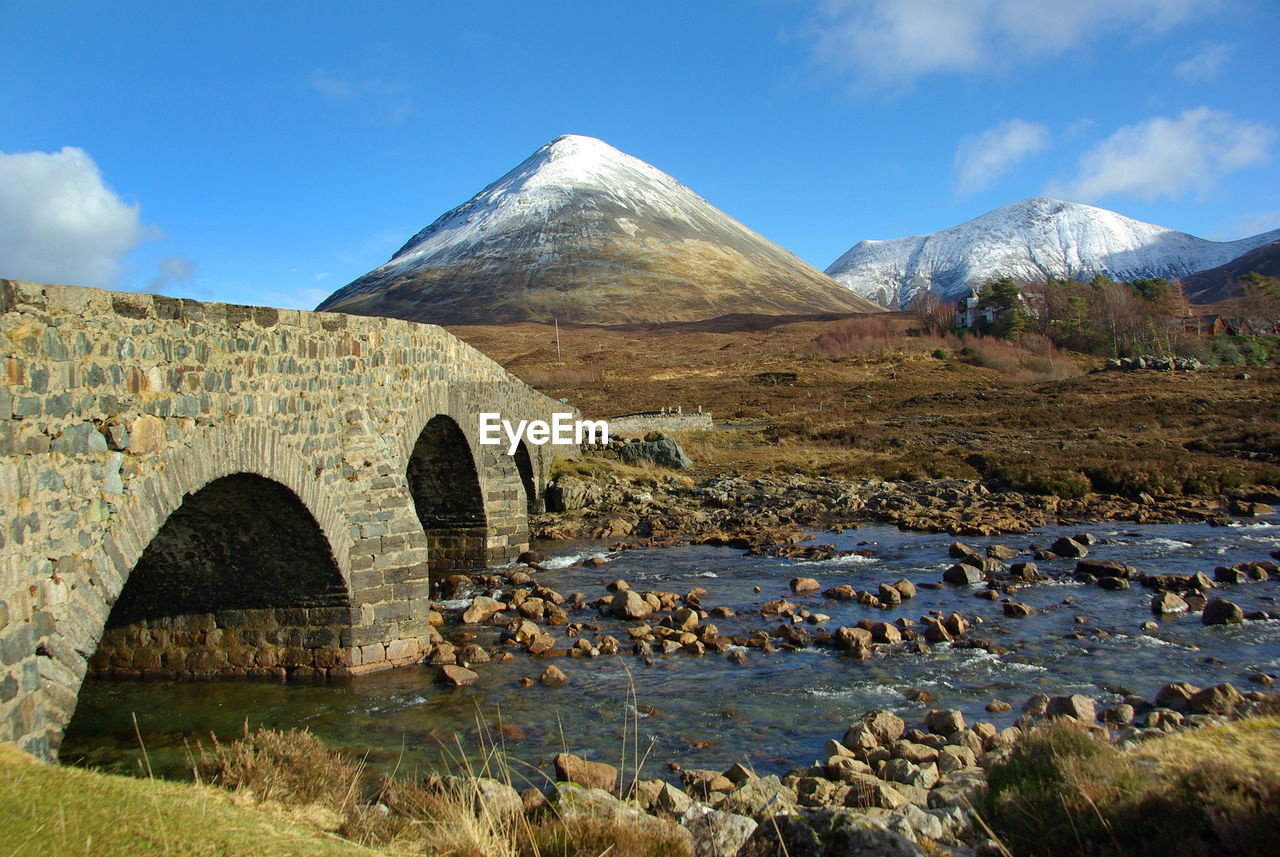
(417, 683, 1280, 857)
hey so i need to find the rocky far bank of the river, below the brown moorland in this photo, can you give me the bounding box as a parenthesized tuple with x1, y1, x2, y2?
(530, 471, 1275, 550)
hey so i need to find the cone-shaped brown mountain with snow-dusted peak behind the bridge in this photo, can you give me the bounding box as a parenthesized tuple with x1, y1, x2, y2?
(317, 136, 879, 324)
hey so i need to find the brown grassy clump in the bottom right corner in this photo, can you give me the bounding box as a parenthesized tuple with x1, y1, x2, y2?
(987, 715, 1280, 857)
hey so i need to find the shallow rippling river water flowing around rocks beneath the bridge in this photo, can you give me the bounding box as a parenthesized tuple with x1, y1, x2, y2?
(61, 524, 1280, 782)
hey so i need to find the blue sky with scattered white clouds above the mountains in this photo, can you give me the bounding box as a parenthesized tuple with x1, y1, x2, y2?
(0, 0, 1280, 308)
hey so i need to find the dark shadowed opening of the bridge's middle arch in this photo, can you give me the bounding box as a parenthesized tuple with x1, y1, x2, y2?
(404, 413, 489, 574)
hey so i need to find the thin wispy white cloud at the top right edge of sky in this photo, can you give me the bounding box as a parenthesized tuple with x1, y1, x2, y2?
(812, 0, 1220, 88)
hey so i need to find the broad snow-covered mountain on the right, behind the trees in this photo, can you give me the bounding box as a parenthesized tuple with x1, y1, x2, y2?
(827, 197, 1280, 308)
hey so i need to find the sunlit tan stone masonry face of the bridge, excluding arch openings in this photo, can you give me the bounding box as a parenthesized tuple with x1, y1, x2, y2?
(0, 280, 563, 757)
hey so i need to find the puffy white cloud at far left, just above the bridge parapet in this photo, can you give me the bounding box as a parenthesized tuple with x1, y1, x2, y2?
(0, 146, 147, 288)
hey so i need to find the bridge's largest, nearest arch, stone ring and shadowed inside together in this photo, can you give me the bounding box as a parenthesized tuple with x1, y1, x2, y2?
(36, 426, 355, 752)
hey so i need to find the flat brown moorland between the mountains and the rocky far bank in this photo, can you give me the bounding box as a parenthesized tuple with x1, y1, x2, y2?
(449, 313, 1280, 501)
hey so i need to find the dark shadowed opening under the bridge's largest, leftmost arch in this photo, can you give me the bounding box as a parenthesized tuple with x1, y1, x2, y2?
(90, 473, 352, 679)
